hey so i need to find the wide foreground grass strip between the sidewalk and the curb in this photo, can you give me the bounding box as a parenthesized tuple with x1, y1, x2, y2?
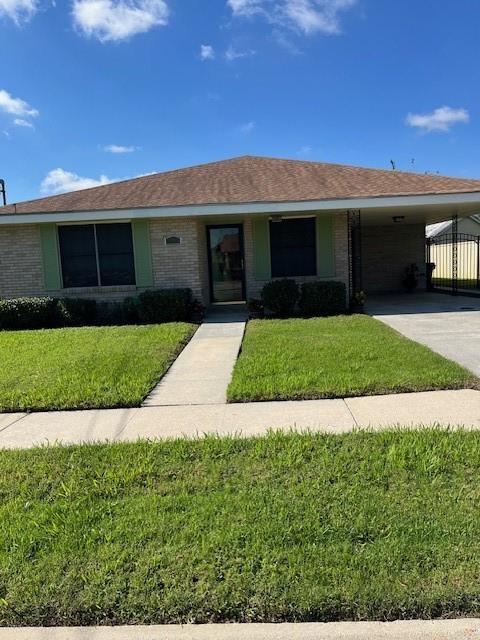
(0, 429, 480, 625)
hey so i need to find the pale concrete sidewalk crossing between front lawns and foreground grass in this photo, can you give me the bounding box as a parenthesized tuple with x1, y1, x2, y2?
(0, 389, 480, 448)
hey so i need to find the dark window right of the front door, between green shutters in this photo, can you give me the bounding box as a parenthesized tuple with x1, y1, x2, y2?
(270, 218, 317, 278)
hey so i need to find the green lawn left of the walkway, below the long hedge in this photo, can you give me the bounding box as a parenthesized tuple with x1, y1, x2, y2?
(0, 323, 193, 411)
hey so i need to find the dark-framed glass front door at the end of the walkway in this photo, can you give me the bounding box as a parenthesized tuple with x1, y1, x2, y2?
(207, 224, 245, 302)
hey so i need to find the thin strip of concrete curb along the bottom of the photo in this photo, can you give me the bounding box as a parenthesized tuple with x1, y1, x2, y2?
(0, 618, 480, 640)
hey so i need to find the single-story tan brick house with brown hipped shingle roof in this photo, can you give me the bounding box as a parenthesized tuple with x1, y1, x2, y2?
(0, 156, 480, 304)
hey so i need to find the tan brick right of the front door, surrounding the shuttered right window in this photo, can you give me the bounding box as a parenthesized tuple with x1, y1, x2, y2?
(243, 213, 348, 298)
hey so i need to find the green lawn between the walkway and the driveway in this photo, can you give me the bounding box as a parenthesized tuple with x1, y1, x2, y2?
(228, 315, 477, 402)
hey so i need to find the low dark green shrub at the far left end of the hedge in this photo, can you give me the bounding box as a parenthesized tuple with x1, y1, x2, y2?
(0, 297, 63, 329)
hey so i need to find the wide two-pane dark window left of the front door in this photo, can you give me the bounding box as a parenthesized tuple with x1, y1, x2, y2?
(58, 222, 135, 288)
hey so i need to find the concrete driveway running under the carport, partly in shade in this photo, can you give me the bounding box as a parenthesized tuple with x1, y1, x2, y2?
(366, 292, 480, 376)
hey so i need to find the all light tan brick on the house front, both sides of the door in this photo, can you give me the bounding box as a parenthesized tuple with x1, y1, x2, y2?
(0, 214, 348, 304)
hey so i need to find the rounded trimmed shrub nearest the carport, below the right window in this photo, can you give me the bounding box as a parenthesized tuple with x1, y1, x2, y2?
(298, 281, 347, 316)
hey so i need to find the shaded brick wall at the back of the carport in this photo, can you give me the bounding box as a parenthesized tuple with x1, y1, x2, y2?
(362, 224, 425, 294)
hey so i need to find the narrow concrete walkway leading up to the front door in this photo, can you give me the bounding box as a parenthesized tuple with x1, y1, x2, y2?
(144, 310, 245, 407)
